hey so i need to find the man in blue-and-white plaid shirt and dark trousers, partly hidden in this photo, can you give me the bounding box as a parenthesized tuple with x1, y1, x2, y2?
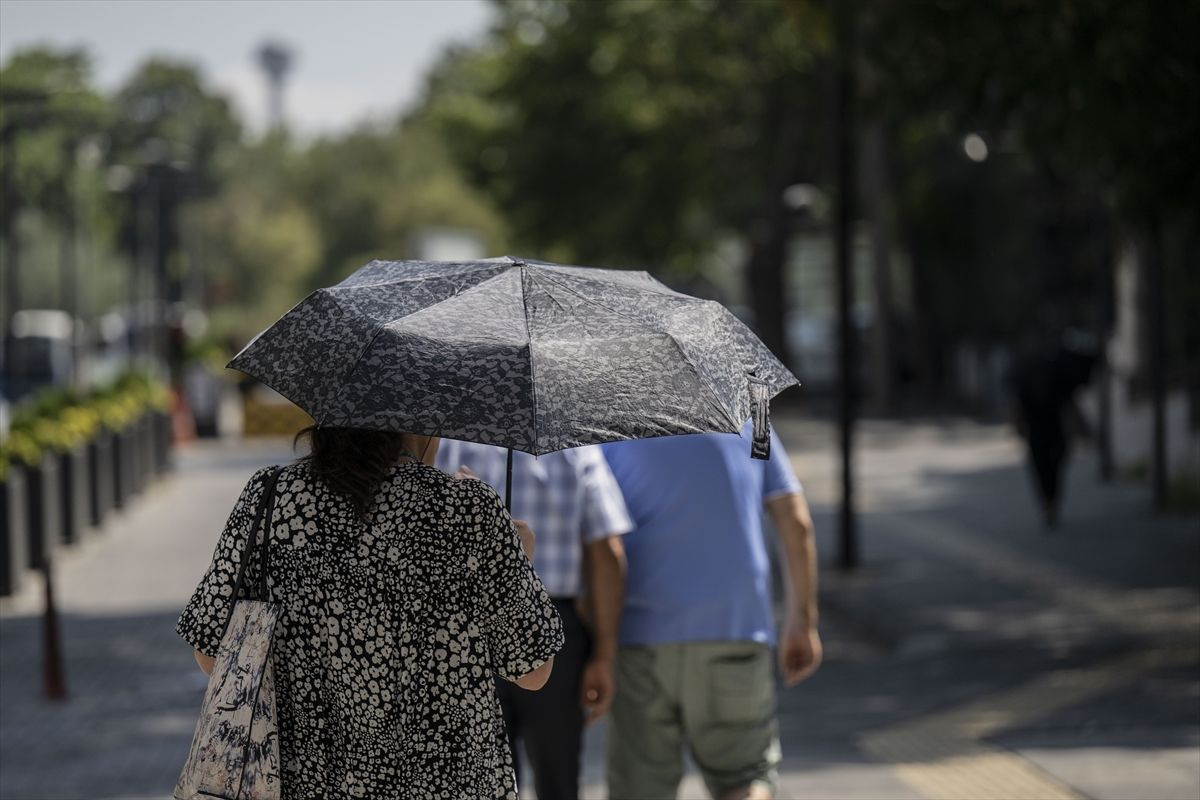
(437, 439, 632, 800)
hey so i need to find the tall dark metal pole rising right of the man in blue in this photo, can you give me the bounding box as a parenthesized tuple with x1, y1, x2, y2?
(834, 0, 859, 570)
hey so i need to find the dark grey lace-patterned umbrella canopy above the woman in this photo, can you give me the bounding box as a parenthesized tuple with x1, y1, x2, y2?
(229, 257, 797, 455)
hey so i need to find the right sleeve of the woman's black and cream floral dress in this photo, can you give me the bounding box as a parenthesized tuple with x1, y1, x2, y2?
(463, 481, 563, 680)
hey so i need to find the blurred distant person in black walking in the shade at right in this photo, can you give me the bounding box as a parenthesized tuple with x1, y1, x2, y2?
(1009, 333, 1099, 529)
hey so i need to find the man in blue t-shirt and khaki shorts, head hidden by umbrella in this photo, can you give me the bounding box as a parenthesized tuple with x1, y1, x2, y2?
(604, 427, 821, 799)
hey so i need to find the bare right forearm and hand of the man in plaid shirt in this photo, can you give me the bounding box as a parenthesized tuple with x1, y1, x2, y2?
(580, 536, 625, 723)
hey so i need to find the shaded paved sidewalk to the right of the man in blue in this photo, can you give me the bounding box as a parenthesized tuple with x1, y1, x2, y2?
(780, 420, 1200, 799)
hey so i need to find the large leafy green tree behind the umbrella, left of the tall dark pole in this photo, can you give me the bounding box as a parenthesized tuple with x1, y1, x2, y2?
(422, 0, 827, 364)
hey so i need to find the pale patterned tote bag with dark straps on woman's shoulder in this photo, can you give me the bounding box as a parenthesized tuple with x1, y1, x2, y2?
(175, 467, 281, 800)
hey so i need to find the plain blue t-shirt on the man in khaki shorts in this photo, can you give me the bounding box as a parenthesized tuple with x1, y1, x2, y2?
(604, 425, 800, 644)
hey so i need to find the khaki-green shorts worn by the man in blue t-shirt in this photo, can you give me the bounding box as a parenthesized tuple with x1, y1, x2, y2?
(608, 642, 780, 800)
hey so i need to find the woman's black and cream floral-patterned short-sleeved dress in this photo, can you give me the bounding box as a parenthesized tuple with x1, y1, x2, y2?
(178, 463, 563, 800)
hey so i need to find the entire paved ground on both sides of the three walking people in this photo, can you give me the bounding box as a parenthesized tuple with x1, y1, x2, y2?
(0, 415, 1200, 800)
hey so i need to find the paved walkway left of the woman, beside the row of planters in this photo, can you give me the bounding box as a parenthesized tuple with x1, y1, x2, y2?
(0, 445, 287, 800)
